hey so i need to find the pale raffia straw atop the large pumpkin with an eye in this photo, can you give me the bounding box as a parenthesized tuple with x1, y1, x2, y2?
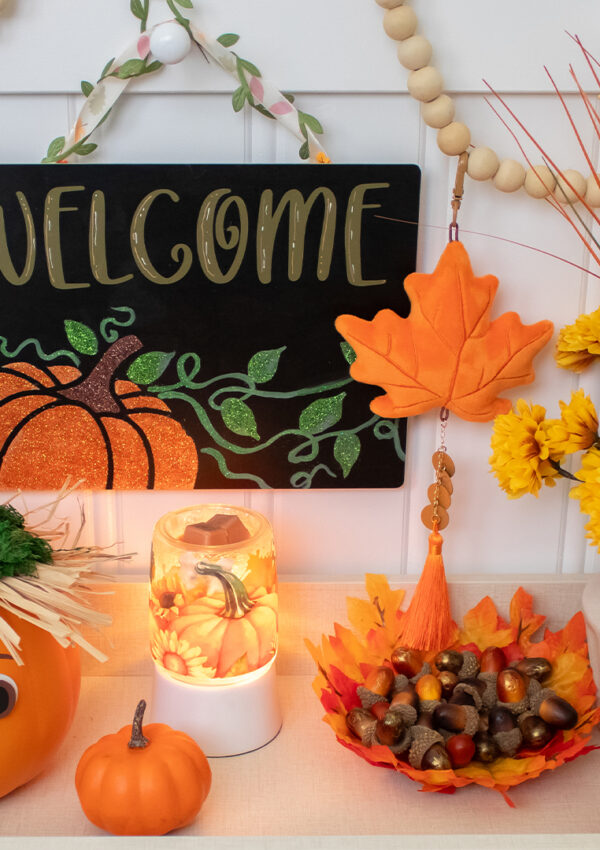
(0, 481, 131, 665)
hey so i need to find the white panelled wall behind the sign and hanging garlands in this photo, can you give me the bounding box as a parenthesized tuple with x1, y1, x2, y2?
(0, 0, 600, 580)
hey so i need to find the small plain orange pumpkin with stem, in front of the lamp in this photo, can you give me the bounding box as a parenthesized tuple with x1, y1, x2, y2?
(75, 700, 212, 835)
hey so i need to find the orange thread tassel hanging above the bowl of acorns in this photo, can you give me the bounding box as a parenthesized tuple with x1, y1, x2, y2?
(400, 523, 455, 651)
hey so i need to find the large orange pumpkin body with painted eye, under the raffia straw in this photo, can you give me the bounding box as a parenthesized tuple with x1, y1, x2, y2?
(0, 611, 81, 797)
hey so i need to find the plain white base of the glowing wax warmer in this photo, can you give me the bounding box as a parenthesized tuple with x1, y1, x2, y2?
(150, 658, 282, 756)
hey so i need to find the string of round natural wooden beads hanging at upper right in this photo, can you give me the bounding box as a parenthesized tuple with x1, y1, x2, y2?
(376, 0, 600, 207)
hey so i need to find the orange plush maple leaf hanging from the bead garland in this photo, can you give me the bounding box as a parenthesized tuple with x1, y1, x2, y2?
(335, 241, 553, 422)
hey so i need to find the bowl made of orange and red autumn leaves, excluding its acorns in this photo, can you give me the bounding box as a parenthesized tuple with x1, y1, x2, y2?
(306, 574, 600, 806)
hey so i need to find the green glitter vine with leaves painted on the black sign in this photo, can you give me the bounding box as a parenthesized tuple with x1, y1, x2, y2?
(0, 306, 405, 486)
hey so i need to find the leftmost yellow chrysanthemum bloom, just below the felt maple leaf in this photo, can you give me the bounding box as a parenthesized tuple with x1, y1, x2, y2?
(490, 399, 561, 499)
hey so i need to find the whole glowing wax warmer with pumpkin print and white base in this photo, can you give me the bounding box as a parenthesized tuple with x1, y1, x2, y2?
(150, 505, 281, 756)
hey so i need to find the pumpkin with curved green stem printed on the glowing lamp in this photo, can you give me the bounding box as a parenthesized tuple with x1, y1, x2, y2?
(172, 565, 277, 677)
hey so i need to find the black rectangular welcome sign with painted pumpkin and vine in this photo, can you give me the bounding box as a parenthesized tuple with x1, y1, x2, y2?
(0, 165, 420, 489)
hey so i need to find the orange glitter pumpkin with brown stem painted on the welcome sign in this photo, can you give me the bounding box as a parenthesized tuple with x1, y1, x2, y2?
(0, 335, 198, 490)
